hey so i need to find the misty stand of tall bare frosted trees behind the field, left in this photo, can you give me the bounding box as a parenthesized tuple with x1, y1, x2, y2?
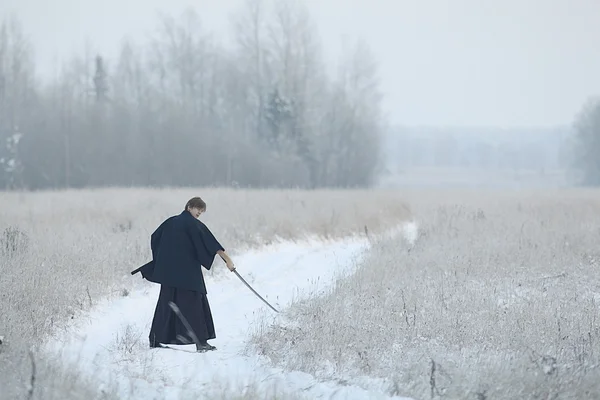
(0, 0, 382, 190)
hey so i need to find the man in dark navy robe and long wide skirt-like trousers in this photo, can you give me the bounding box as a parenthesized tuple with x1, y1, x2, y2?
(145, 197, 235, 352)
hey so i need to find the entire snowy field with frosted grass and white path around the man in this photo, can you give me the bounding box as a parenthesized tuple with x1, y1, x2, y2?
(0, 189, 600, 400)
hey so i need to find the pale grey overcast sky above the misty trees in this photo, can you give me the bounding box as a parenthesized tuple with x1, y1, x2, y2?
(0, 0, 600, 128)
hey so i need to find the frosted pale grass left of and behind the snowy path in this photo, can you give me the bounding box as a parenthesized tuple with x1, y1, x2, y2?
(0, 188, 409, 400)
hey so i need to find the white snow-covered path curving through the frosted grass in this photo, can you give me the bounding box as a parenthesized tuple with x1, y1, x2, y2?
(47, 225, 416, 399)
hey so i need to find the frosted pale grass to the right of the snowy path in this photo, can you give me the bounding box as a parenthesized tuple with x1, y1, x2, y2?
(253, 190, 600, 400)
